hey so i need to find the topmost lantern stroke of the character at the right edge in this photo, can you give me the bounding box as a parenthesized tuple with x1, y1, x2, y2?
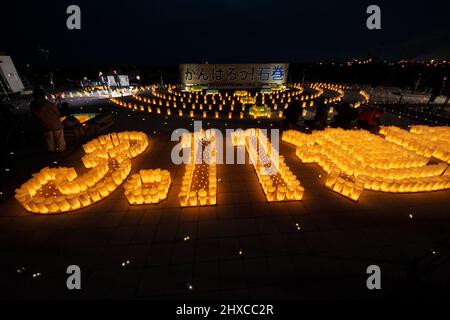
(380, 125, 450, 163)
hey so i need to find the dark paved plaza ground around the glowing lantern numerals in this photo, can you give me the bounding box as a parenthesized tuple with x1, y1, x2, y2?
(0, 102, 450, 299)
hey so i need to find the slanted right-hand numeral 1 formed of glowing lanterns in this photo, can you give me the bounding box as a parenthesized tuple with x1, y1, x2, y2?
(231, 129, 304, 202)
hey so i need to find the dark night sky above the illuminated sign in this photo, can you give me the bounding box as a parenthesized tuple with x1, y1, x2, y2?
(0, 0, 450, 67)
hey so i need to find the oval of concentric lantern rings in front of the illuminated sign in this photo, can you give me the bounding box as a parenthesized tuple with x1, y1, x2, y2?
(110, 83, 343, 119)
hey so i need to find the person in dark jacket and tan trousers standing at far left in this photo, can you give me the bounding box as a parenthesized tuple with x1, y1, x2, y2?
(30, 88, 66, 152)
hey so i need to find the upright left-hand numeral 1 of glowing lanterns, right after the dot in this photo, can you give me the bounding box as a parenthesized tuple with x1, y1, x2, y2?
(178, 130, 217, 207)
